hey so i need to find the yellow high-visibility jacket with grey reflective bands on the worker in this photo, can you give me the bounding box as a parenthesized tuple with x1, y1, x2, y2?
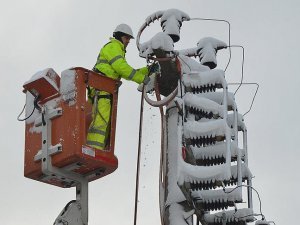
(94, 38, 148, 84)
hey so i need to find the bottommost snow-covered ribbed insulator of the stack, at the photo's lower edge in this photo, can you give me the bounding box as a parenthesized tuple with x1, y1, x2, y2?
(203, 208, 255, 225)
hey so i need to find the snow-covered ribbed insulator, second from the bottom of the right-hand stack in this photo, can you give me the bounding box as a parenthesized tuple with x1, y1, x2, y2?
(191, 188, 243, 211)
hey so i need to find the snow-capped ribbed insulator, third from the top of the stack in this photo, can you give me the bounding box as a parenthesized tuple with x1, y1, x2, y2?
(184, 119, 231, 144)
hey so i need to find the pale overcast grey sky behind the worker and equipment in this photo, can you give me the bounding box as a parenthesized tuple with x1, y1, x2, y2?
(0, 0, 300, 225)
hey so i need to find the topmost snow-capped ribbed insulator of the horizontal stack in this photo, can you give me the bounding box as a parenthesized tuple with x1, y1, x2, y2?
(182, 69, 226, 94)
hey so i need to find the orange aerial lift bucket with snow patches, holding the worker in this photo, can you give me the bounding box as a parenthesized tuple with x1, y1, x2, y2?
(23, 67, 121, 187)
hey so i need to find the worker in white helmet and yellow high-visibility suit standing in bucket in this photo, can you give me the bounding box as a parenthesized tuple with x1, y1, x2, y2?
(87, 24, 158, 151)
